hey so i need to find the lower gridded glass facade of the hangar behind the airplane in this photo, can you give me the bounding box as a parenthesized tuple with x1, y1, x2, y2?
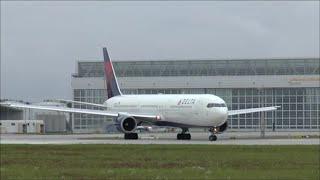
(74, 88, 320, 129)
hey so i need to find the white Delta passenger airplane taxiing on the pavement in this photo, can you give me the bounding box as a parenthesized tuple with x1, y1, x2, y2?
(1, 47, 279, 141)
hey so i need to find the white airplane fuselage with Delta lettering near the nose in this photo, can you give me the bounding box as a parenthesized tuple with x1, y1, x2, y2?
(104, 94, 228, 127)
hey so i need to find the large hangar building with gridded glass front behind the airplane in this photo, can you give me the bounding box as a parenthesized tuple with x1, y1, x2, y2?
(72, 58, 320, 133)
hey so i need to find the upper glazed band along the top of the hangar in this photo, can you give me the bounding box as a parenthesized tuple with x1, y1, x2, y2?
(75, 58, 319, 77)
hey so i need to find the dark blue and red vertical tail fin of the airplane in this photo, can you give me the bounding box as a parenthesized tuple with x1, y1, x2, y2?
(103, 47, 122, 99)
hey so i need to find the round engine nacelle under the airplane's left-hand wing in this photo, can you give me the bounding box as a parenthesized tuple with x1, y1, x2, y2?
(116, 114, 137, 133)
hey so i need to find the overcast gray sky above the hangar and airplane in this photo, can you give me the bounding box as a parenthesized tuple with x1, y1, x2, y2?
(1, 1, 319, 101)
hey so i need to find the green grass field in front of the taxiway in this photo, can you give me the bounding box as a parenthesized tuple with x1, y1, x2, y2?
(0, 145, 320, 180)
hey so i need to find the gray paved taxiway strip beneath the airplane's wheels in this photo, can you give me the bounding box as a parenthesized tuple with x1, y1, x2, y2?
(0, 132, 320, 145)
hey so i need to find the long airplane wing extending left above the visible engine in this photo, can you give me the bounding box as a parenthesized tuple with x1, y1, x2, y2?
(0, 102, 159, 122)
